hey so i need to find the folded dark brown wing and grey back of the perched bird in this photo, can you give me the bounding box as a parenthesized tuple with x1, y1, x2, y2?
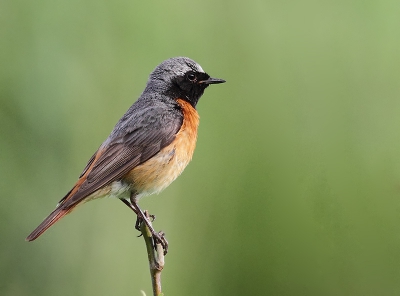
(59, 102, 183, 208)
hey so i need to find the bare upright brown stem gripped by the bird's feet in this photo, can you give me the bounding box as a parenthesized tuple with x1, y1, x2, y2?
(140, 211, 164, 296)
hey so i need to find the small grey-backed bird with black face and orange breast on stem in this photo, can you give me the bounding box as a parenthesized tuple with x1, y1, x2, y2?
(26, 57, 226, 253)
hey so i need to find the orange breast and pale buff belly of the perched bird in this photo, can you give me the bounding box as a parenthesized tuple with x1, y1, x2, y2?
(126, 99, 199, 199)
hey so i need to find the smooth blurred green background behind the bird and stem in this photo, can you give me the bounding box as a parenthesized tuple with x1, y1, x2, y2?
(0, 0, 400, 296)
